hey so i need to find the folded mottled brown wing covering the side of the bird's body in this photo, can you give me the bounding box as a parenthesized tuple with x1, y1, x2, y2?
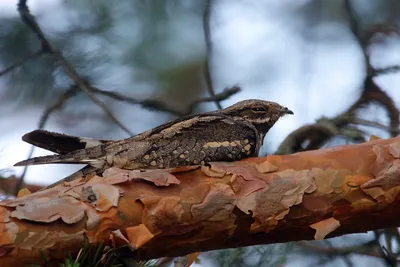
(106, 114, 259, 169)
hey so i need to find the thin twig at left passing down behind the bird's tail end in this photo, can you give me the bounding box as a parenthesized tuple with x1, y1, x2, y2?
(15, 85, 78, 194)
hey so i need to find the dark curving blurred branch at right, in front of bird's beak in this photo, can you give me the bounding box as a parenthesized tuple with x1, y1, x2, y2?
(276, 0, 400, 154)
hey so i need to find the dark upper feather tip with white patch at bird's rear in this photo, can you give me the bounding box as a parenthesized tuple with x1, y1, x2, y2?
(22, 130, 112, 154)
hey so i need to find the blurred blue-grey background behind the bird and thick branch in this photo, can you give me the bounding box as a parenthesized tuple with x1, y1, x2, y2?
(0, 0, 400, 267)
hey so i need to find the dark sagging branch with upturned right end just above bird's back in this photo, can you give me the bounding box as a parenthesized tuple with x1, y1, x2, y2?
(91, 86, 240, 116)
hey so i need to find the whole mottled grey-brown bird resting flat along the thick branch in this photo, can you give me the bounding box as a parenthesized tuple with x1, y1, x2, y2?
(15, 100, 293, 187)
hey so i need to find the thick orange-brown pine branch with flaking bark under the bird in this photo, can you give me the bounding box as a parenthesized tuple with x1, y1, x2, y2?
(0, 137, 400, 266)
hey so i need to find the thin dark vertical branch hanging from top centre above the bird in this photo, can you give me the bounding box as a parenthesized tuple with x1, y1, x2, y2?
(203, 0, 222, 109)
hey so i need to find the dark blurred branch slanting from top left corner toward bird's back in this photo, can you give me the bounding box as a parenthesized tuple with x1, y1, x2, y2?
(18, 0, 133, 135)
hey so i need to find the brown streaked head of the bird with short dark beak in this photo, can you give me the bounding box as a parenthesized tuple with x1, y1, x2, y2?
(221, 99, 294, 132)
